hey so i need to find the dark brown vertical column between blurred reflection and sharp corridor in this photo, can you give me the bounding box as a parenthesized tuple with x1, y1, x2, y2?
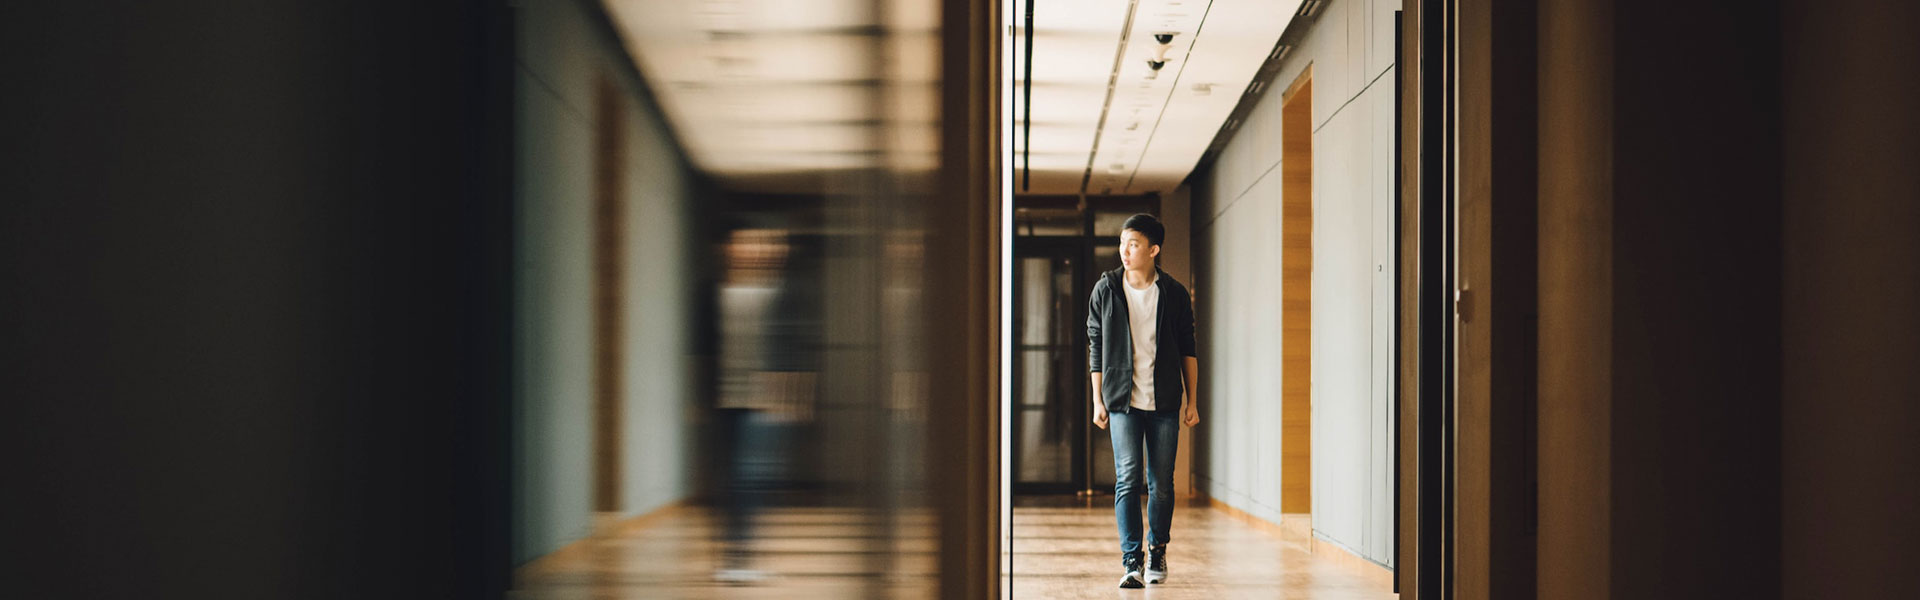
(924, 0, 1010, 600)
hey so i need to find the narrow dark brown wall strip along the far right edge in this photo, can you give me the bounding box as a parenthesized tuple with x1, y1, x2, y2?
(1780, 0, 1920, 598)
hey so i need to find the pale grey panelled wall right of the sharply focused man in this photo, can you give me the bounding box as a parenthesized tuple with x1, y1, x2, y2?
(1192, 0, 1400, 565)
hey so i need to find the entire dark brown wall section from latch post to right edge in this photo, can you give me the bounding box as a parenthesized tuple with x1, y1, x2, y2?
(1538, 0, 1920, 598)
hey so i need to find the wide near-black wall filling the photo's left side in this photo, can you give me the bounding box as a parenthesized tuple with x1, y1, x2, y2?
(0, 0, 511, 598)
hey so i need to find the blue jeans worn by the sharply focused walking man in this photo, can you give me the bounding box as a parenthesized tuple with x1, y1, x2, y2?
(1108, 412, 1181, 556)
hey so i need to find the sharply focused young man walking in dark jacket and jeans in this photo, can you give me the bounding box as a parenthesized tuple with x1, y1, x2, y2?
(1087, 215, 1200, 588)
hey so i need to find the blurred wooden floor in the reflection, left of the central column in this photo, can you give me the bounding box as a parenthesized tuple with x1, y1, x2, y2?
(509, 508, 937, 600)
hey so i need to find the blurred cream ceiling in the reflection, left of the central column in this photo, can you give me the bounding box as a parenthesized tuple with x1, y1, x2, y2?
(603, 0, 939, 192)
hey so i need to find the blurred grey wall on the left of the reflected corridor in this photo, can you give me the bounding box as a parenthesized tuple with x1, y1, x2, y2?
(515, 0, 691, 562)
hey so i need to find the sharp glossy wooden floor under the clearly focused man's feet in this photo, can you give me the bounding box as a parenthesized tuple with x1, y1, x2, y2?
(1008, 496, 1394, 600)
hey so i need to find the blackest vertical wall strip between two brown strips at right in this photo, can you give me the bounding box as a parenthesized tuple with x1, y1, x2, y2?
(1611, 2, 1782, 598)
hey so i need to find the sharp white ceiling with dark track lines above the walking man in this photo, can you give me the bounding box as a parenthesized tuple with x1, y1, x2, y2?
(1010, 0, 1300, 194)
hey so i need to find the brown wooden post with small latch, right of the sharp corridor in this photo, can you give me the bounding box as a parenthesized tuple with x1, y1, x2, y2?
(1453, 0, 1538, 598)
